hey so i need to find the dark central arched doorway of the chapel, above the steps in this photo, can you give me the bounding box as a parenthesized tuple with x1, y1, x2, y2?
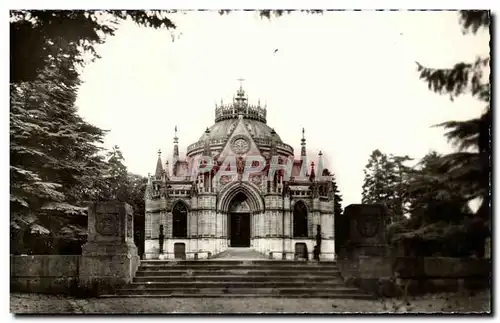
(228, 192, 254, 247)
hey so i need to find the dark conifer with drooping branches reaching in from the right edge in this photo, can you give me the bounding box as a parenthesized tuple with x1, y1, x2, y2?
(417, 10, 492, 223)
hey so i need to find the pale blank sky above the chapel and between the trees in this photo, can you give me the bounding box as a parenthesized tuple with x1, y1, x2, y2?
(77, 11, 489, 206)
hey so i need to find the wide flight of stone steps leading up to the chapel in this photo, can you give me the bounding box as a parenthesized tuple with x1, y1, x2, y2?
(102, 259, 373, 299)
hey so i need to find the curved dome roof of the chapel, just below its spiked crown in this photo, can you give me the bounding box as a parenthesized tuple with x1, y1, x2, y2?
(200, 118, 281, 142)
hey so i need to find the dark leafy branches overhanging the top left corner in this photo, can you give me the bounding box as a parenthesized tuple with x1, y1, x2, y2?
(10, 10, 175, 83)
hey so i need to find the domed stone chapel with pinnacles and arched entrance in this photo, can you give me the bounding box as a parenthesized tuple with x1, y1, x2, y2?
(145, 87, 335, 259)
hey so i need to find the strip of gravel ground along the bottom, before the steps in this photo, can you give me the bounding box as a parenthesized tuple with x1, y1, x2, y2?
(10, 291, 491, 314)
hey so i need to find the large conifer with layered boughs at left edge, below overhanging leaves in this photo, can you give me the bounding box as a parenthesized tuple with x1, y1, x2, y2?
(10, 62, 105, 230)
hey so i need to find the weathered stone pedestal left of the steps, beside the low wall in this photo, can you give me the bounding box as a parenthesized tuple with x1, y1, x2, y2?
(79, 202, 140, 294)
